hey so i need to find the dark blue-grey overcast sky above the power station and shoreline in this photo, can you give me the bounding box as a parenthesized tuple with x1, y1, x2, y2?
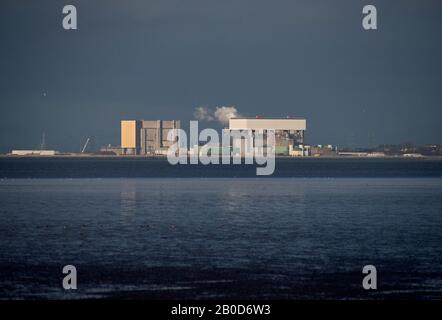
(0, 0, 442, 152)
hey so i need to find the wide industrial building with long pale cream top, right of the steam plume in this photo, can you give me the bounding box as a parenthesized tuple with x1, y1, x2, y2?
(229, 117, 306, 156)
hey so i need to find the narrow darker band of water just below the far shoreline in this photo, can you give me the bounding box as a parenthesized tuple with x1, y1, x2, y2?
(0, 157, 442, 179)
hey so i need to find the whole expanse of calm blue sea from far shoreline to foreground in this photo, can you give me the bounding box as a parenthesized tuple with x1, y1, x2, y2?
(0, 159, 442, 299)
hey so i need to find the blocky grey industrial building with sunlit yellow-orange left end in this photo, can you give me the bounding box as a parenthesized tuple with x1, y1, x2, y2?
(121, 120, 181, 155)
